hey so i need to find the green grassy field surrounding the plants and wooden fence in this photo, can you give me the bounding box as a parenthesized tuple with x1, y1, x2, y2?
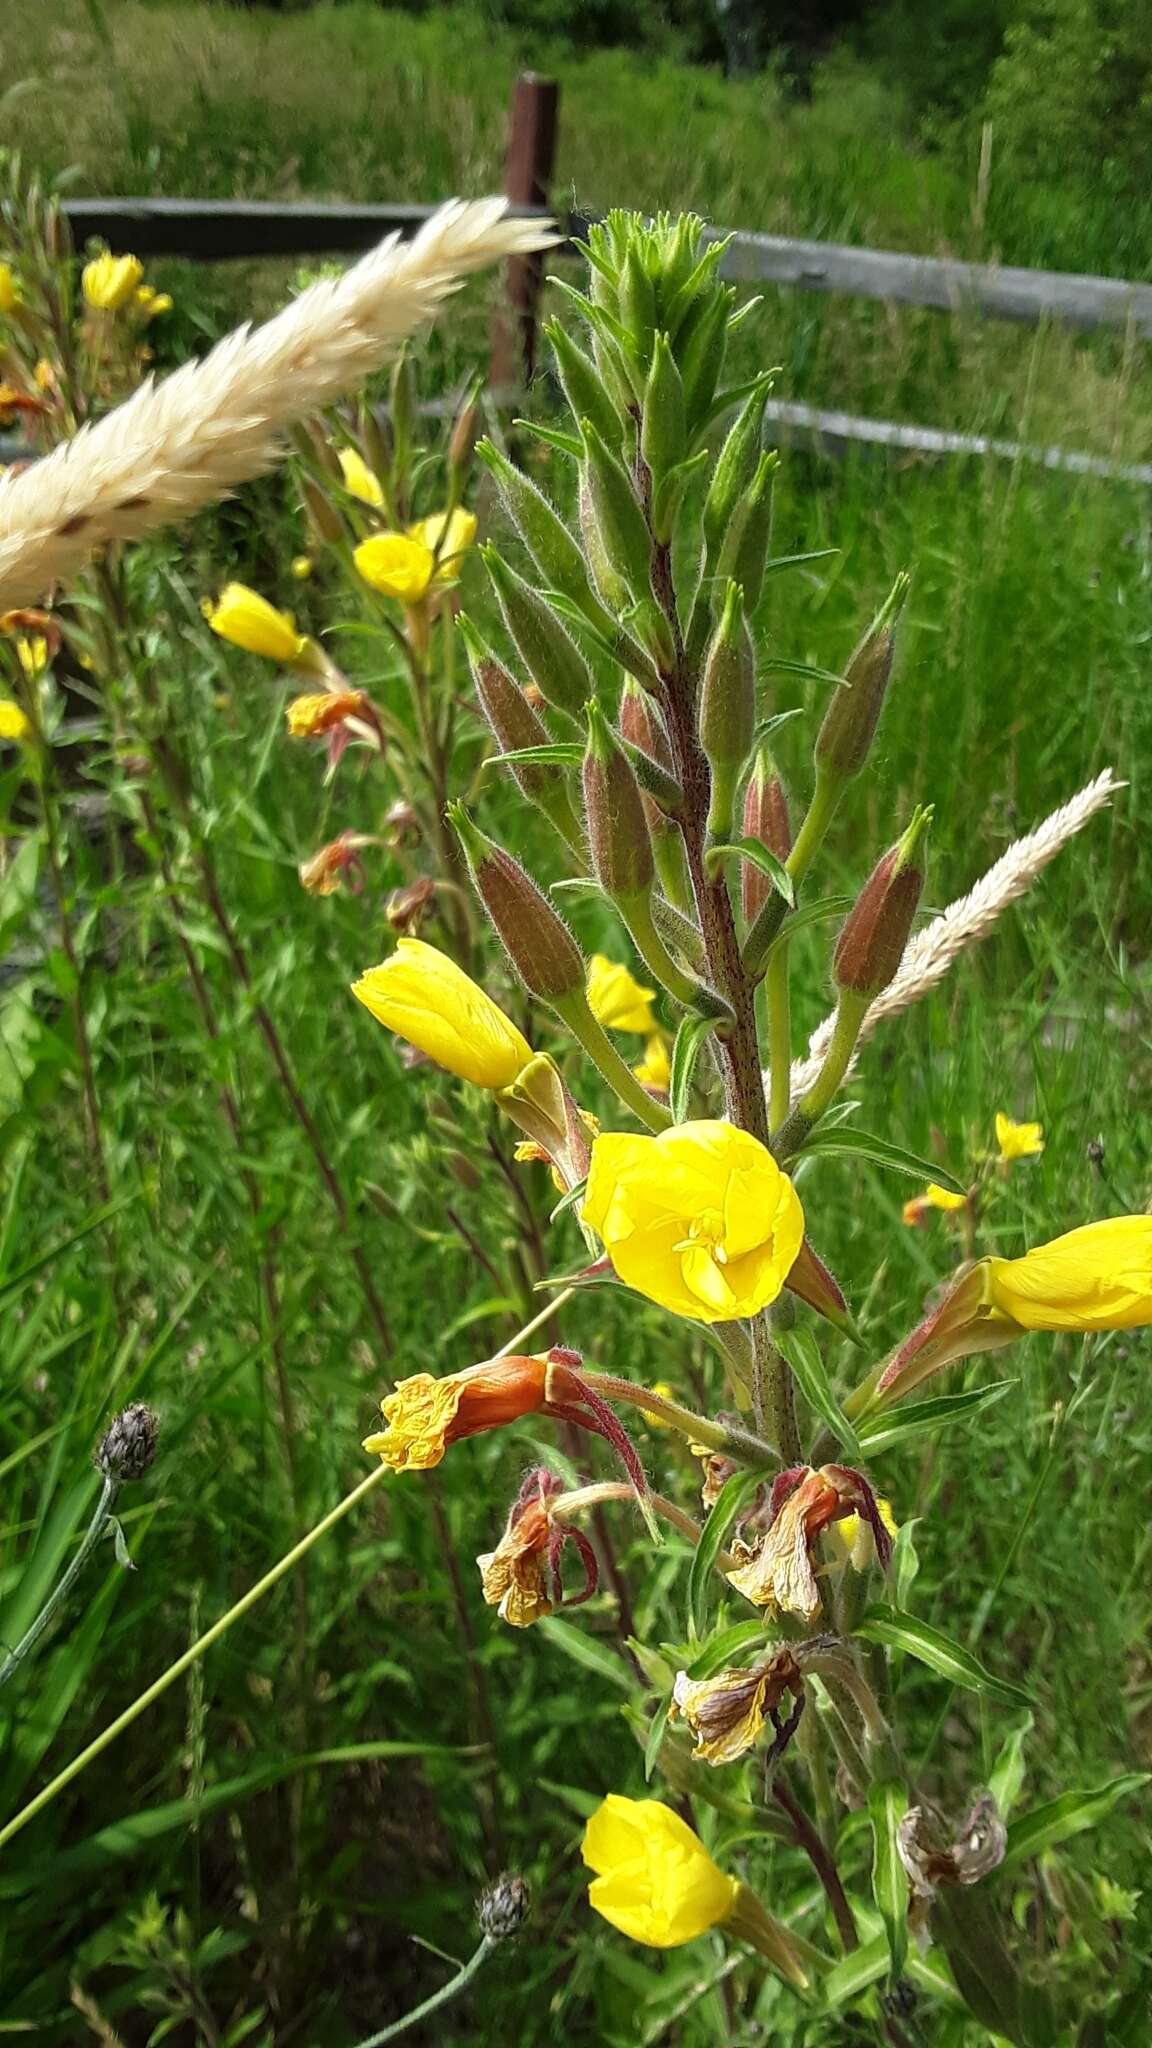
(0, 0, 1152, 2048)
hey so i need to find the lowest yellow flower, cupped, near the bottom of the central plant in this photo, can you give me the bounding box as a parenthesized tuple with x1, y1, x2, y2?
(584, 1792, 738, 1948)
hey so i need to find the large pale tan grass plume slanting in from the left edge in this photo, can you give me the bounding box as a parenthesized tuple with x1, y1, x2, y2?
(0, 199, 556, 610)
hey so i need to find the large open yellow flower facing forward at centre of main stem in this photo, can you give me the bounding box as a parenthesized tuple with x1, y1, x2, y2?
(584, 1120, 804, 1323)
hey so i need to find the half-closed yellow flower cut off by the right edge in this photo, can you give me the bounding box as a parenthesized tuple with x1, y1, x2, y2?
(975, 1217, 1152, 1329)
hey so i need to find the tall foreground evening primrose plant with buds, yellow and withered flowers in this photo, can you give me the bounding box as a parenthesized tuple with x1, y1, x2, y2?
(344, 213, 1152, 2048)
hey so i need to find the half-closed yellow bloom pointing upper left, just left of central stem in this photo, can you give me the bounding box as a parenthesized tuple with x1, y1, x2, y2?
(353, 938, 533, 1087)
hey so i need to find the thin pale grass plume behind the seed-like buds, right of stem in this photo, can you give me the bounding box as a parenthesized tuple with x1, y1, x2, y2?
(791, 768, 1125, 1102)
